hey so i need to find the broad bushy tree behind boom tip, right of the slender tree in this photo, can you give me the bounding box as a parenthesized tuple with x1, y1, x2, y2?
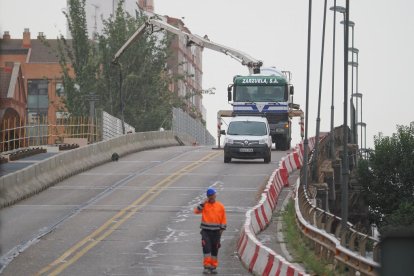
(99, 4, 176, 131)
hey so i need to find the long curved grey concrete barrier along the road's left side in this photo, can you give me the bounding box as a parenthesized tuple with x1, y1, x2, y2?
(0, 131, 194, 208)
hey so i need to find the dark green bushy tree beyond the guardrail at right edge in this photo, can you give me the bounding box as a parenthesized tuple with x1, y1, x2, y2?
(358, 126, 414, 231)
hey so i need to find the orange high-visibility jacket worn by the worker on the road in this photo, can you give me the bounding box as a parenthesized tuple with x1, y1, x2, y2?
(194, 201, 227, 230)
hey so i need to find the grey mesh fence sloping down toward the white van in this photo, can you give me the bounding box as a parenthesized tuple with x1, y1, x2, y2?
(172, 108, 216, 145)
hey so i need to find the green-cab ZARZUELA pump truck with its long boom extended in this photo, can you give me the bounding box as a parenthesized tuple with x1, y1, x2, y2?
(112, 17, 303, 150)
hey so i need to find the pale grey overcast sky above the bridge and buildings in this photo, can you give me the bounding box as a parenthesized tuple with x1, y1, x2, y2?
(0, 0, 414, 147)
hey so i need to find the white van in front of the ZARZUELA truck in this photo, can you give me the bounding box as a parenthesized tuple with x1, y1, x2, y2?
(221, 116, 272, 163)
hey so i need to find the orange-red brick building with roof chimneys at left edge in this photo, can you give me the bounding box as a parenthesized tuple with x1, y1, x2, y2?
(0, 29, 73, 147)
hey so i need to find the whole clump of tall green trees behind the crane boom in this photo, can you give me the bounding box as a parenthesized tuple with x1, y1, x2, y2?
(58, 0, 182, 131)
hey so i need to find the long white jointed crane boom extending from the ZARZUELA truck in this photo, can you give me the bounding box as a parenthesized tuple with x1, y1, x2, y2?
(112, 17, 263, 74)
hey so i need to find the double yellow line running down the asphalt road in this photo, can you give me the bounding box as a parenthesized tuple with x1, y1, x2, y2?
(36, 152, 221, 275)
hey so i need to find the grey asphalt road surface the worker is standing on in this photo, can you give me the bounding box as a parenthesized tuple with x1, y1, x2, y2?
(0, 147, 286, 275)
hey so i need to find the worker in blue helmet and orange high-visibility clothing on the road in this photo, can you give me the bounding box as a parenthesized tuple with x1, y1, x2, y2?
(194, 188, 227, 274)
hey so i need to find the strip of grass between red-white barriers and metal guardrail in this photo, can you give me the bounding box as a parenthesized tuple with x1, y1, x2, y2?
(282, 200, 338, 275)
